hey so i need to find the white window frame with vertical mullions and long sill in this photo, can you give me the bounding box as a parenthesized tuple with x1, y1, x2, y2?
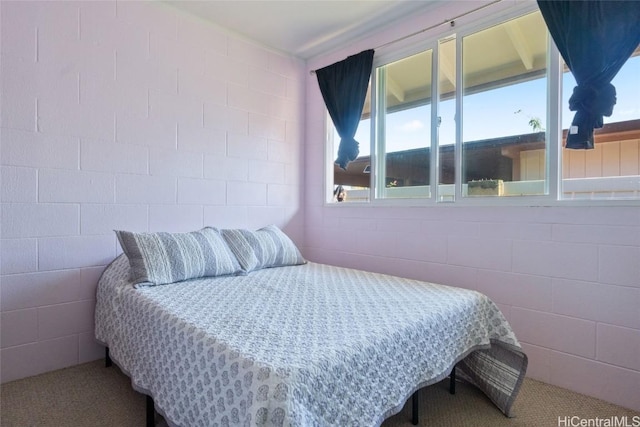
(324, 3, 640, 207)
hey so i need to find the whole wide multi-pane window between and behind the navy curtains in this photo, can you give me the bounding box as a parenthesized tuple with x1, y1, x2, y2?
(332, 3, 640, 204)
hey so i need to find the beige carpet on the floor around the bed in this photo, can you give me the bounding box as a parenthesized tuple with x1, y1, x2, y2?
(0, 361, 640, 427)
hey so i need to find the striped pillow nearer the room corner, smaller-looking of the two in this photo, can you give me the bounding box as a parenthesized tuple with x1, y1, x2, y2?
(222, 225, 307, 273)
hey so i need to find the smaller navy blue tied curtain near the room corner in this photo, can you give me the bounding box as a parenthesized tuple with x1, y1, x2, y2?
(316, 49, 374, 170)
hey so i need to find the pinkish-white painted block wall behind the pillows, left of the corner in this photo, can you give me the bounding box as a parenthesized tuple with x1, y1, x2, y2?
(0, 1, 305, 382)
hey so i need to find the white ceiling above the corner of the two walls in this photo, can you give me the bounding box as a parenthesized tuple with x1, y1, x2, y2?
(166, 0, 440, 59)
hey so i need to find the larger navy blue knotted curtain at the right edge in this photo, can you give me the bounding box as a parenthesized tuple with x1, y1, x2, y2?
(538, 0, 640, 149)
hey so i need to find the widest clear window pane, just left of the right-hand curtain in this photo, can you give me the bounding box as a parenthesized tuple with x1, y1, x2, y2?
(462, 12, 547, 197)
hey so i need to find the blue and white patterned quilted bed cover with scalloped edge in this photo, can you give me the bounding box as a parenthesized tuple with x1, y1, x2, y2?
(95, 256, 527, 427)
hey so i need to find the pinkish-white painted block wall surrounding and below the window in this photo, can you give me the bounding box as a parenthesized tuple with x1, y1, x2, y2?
(304, 2, 640, 410)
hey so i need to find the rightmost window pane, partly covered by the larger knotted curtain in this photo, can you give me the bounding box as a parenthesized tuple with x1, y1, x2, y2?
(562, 47, 640, 199)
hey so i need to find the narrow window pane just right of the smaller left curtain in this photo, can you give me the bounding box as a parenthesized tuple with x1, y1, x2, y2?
(376, 50, 433, 198)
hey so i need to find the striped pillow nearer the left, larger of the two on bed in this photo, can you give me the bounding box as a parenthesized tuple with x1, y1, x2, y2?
(116, 227, 242, 285)
